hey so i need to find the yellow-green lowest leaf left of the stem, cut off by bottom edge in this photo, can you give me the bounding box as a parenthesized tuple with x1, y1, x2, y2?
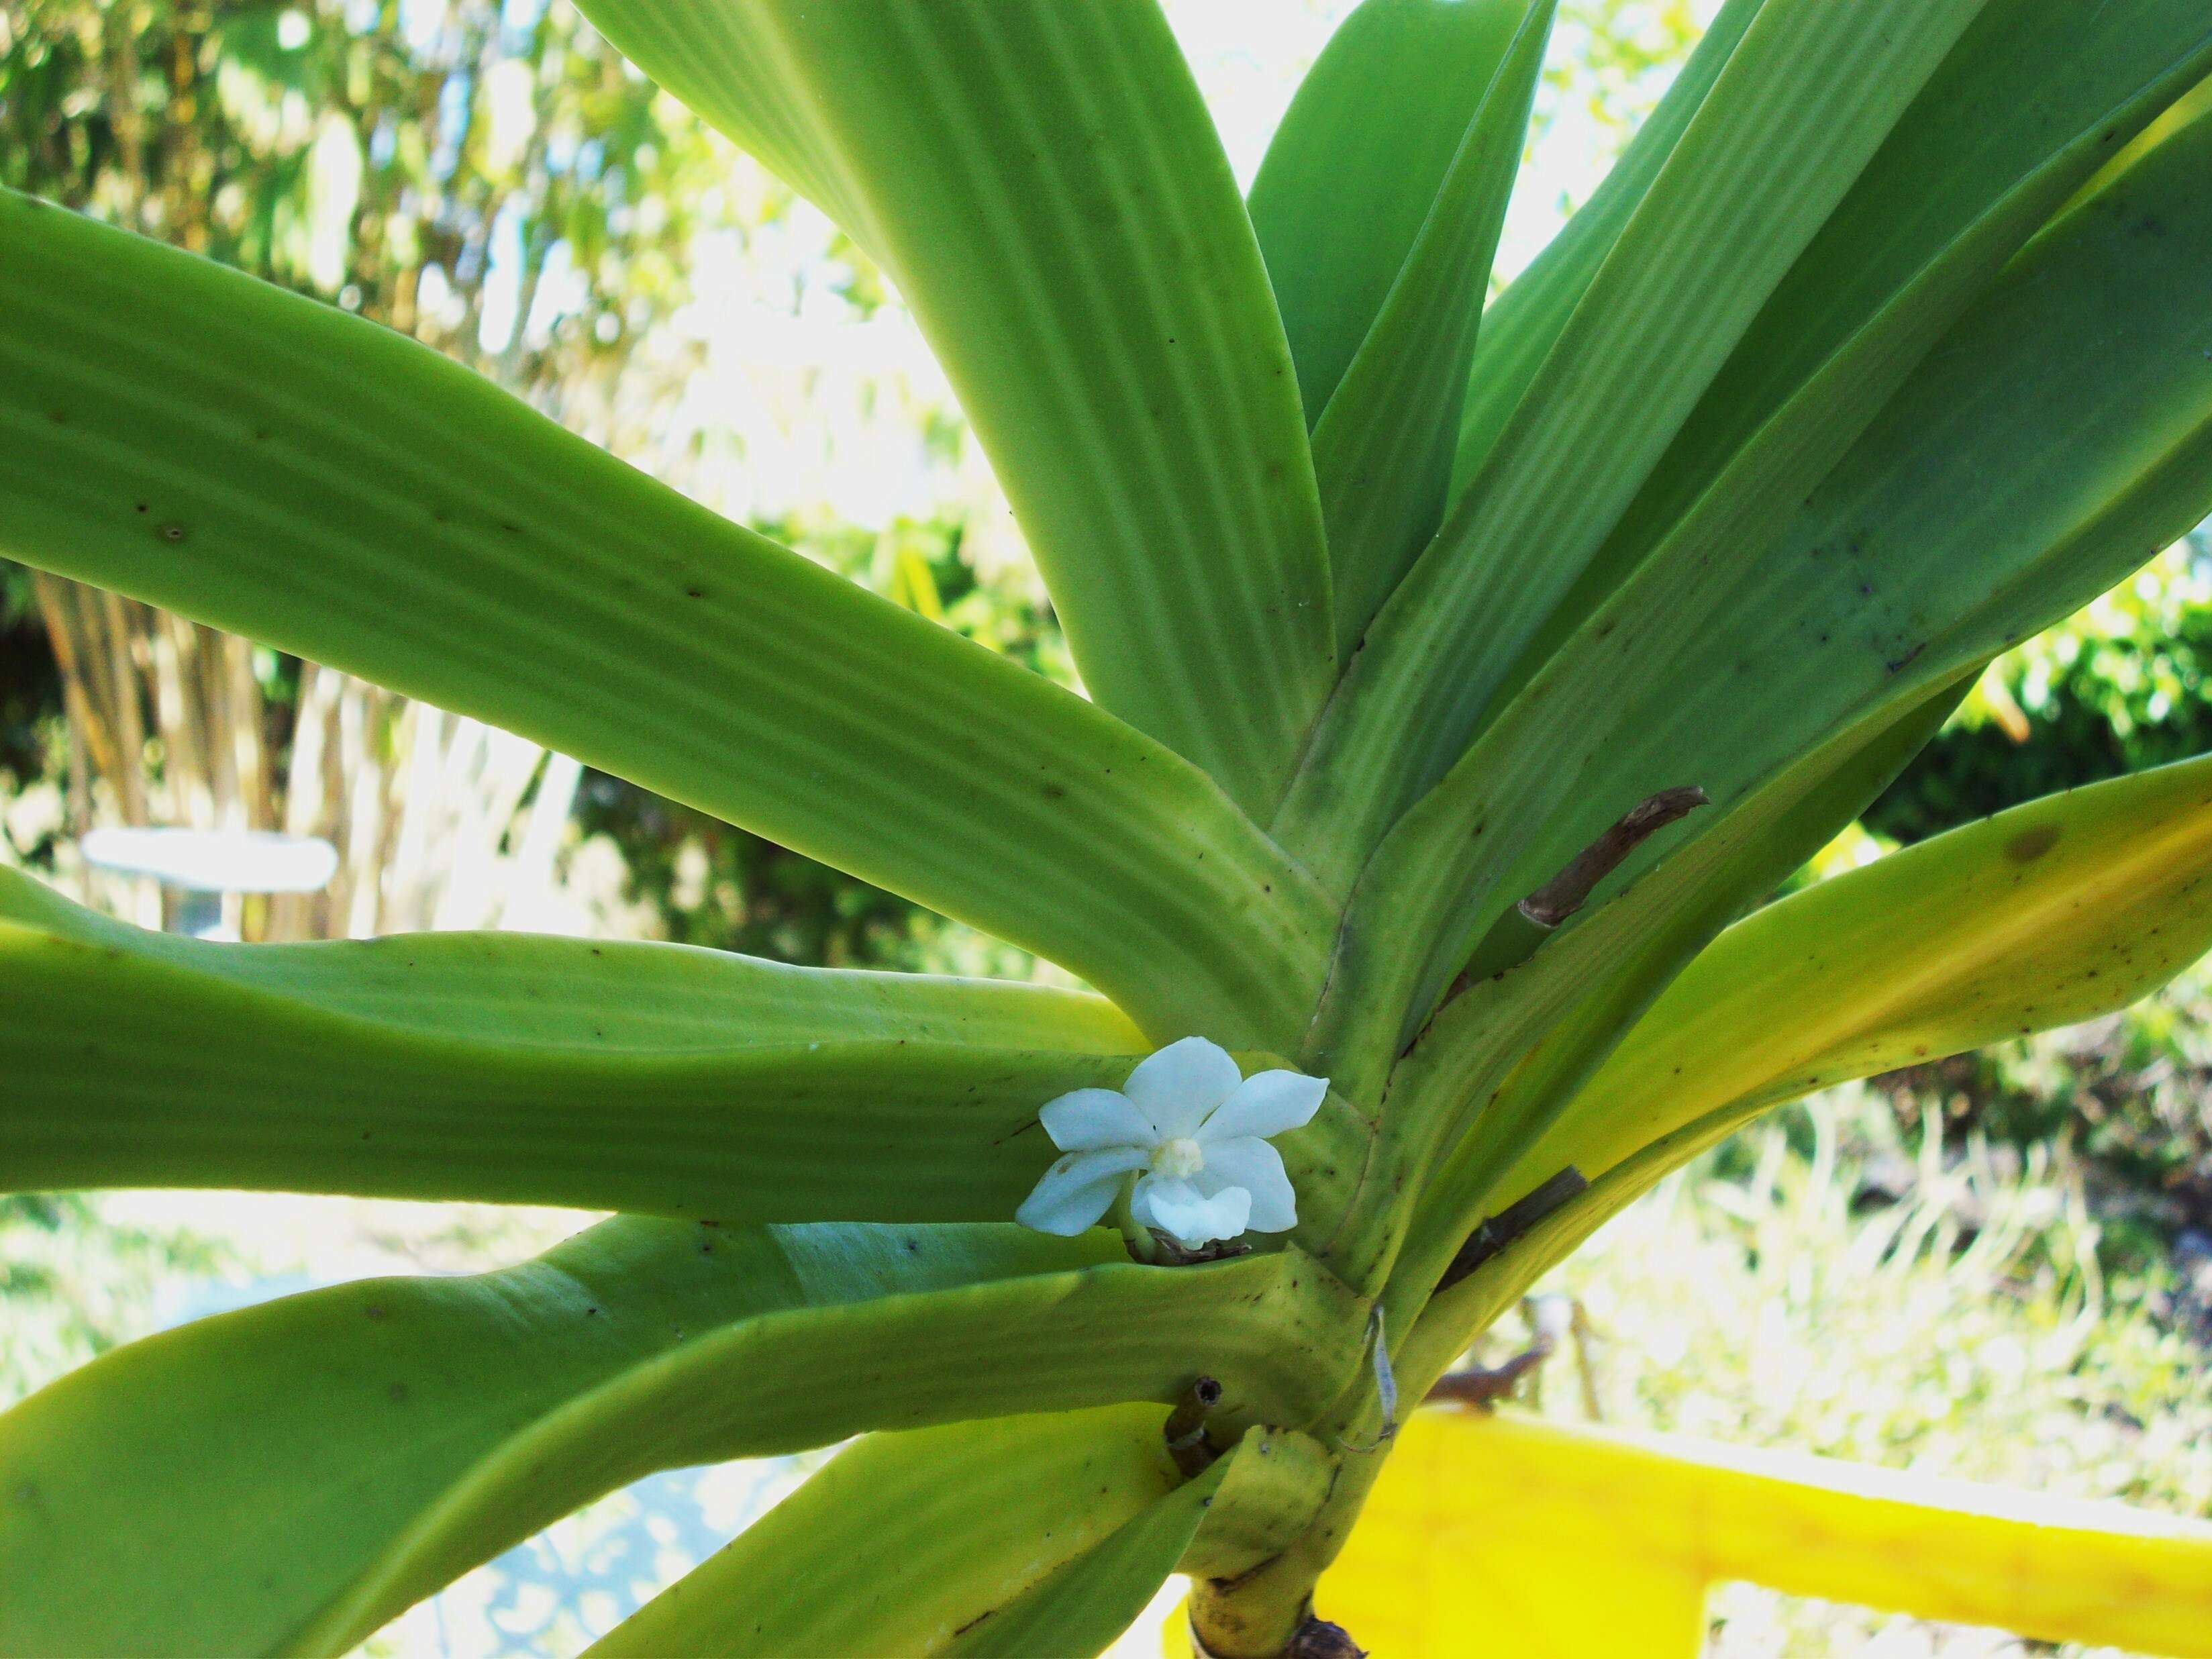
(591, 1407, 1181, 1659)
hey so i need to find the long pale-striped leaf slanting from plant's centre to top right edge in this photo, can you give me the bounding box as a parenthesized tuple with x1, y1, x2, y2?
(1280, 0, 1984, 881)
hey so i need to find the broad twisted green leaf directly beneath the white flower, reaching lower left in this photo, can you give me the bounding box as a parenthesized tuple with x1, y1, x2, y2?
(0, 1219, 1362, 1654)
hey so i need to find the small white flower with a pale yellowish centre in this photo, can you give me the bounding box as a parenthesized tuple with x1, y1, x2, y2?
(1013, 1038, 1329, 1250)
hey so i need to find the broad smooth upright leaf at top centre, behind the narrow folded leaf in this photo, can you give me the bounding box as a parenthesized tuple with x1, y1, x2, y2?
(1246, 0, 1529, 436)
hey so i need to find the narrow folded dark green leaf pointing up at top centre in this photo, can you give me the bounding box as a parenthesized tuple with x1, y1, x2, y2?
(1314, 0, 1557, 657)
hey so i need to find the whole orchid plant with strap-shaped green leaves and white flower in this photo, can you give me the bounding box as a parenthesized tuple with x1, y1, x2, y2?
(0, 0, 2212, 1659)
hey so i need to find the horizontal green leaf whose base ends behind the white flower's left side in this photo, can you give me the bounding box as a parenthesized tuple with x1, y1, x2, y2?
(0, 872, 1144, 1221)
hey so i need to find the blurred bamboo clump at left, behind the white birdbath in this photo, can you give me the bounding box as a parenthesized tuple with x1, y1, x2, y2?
(0, 0, 721, 938)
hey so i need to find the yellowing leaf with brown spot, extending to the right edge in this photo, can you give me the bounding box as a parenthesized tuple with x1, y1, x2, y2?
(1403, 759, 2212, 1372)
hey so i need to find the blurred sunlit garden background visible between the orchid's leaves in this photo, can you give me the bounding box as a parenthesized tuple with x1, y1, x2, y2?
(0, 0, 2212, 1654)
